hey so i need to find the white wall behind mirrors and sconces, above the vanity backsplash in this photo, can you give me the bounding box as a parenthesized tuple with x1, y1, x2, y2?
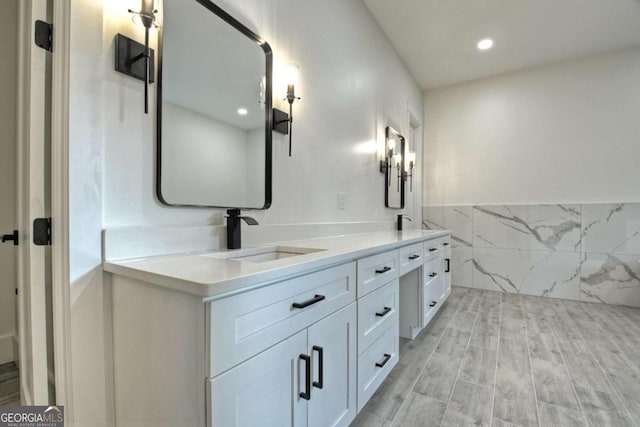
(103, 0, 422, 227)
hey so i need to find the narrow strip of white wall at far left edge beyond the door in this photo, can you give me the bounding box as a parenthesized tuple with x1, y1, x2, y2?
(0, 0, 18, 364)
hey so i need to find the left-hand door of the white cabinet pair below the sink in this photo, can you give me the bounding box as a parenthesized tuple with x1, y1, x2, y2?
(207, 330, 310, 427)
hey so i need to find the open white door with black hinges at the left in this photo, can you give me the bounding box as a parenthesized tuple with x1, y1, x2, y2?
(17, 0, 53, 405)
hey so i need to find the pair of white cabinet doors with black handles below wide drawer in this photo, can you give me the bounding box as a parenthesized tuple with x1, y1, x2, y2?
(207, 304, 356, 427)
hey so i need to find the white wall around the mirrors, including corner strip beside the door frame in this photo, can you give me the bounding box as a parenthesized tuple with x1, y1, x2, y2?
(69, 0, 422, 425)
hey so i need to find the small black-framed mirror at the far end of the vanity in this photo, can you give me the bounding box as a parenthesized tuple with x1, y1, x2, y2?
(383, 126, 405, 209)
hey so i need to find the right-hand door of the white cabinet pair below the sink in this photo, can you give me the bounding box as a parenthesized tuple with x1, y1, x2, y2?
(307, 303, 358, 427)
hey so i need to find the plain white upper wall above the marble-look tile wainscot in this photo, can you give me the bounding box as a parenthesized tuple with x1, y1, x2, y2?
(423, 49, 640, 205)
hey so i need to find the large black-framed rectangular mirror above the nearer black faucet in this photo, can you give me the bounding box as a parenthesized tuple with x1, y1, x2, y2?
(156, 0, 272, 209)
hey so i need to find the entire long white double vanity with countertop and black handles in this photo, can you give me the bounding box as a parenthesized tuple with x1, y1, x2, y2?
(104, 230, 451, 426)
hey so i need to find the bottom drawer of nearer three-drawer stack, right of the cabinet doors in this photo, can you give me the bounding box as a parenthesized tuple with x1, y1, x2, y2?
(358, 322, 399, 412)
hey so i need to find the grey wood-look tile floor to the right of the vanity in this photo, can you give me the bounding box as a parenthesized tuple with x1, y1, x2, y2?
(351, 287, 640, 427)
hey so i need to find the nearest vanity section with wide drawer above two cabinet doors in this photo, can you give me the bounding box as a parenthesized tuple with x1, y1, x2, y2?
(207, 262, 357, 427)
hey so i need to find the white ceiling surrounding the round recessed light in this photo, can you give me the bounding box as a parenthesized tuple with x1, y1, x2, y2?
(363, 0, 640, 89)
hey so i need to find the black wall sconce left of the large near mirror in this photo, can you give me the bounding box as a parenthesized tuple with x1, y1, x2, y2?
(115, 0, 158, 114)
